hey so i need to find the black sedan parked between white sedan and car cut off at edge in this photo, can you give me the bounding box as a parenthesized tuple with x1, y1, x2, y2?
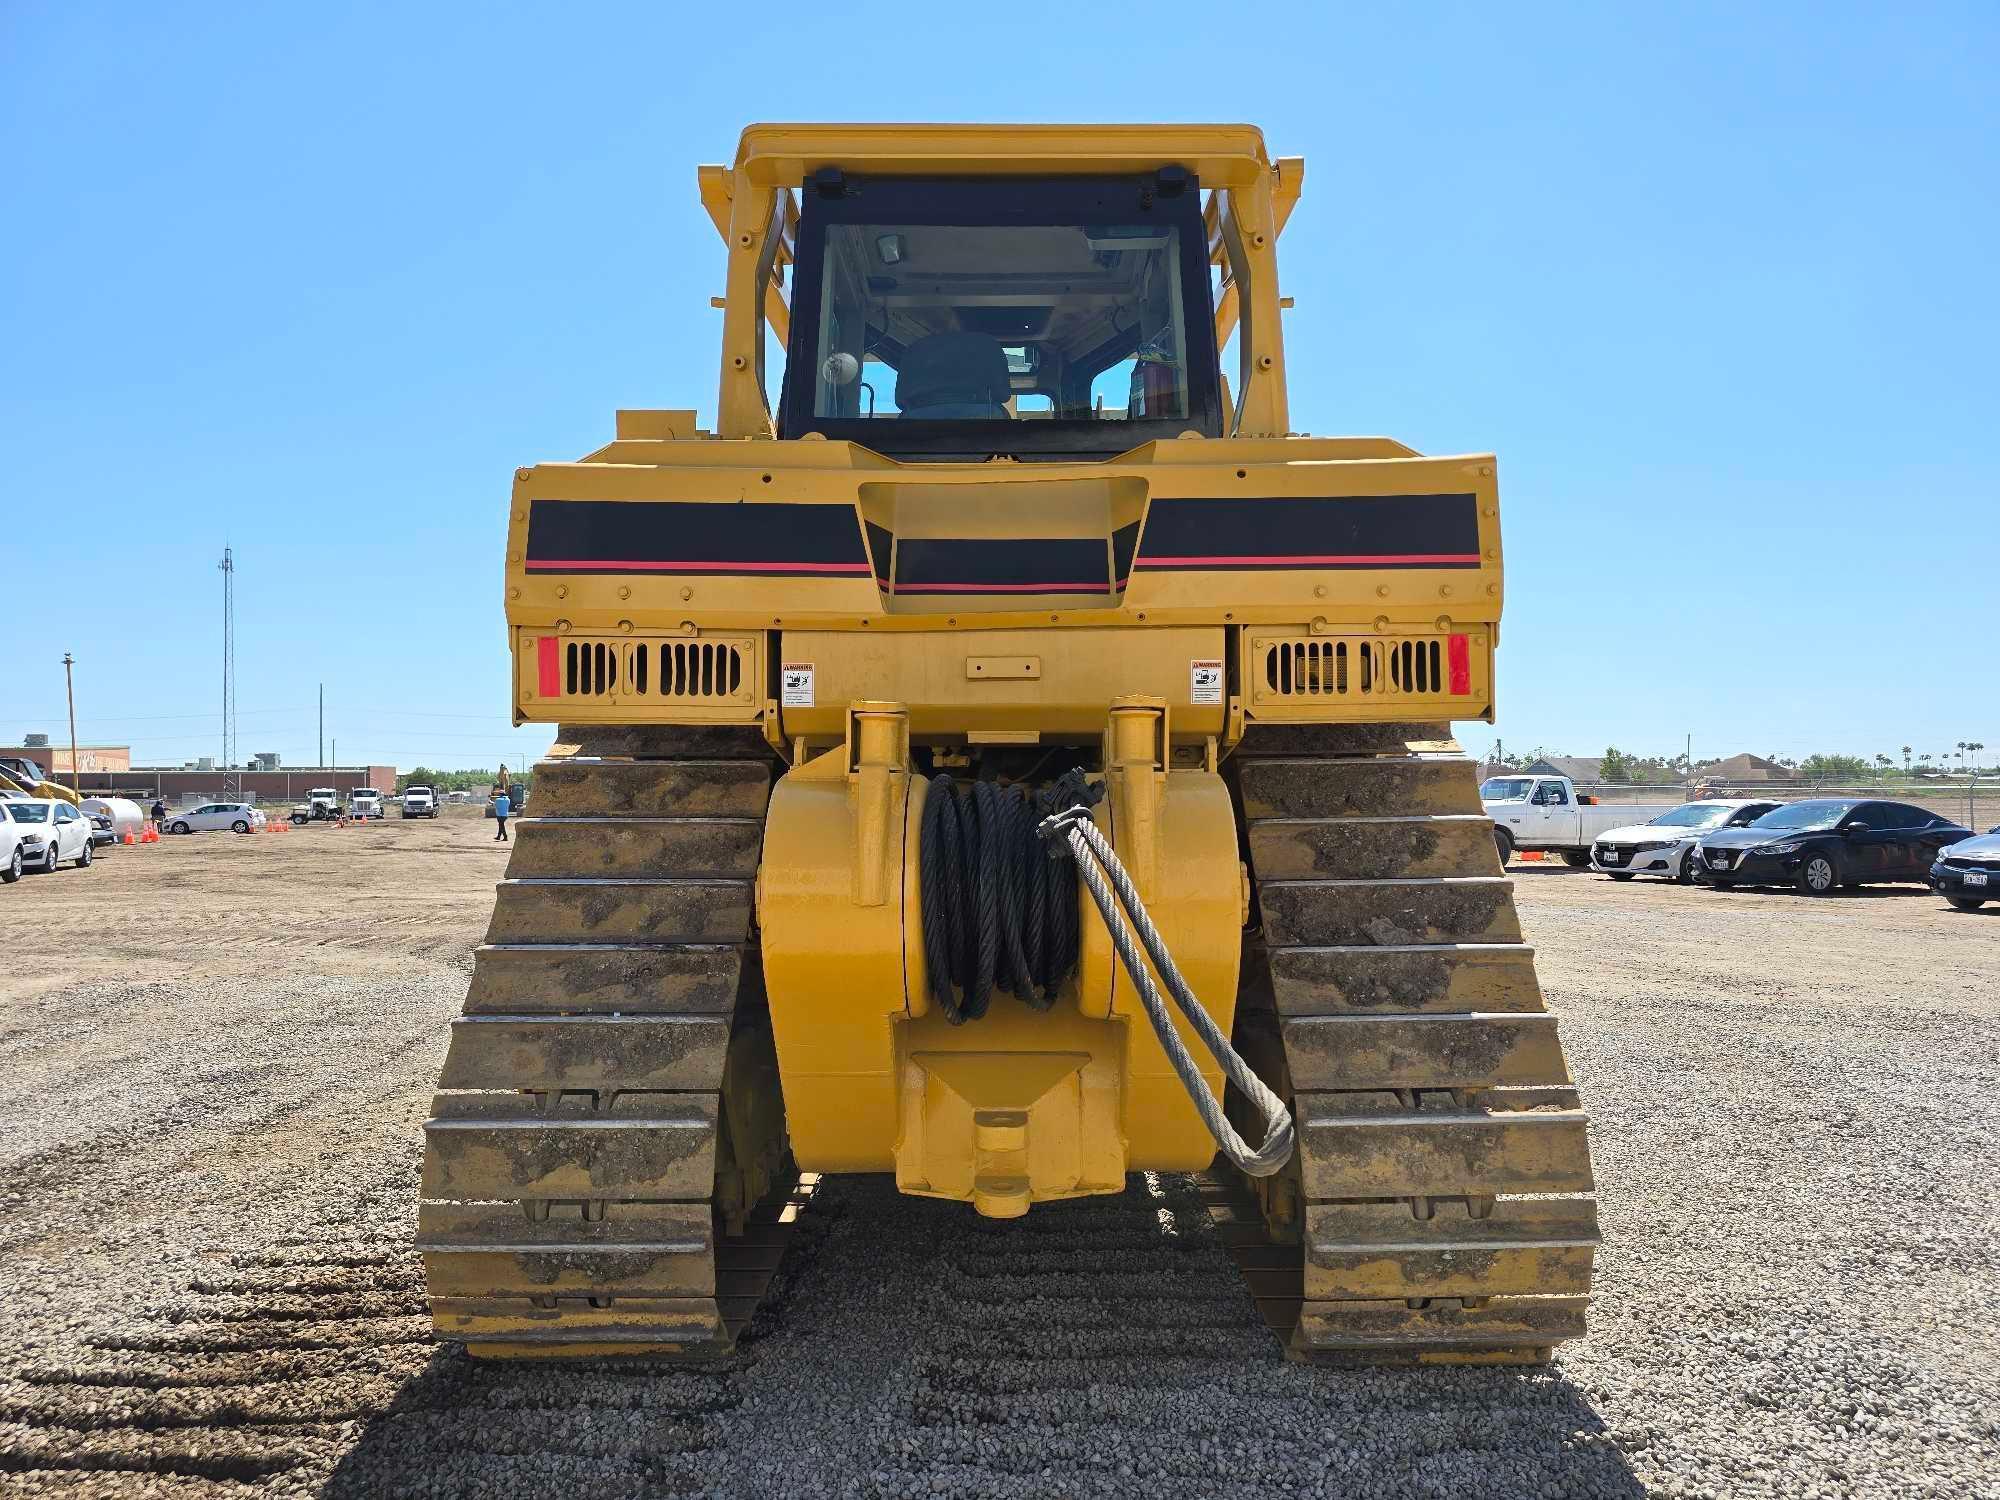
(1700, 796, 1972, 896)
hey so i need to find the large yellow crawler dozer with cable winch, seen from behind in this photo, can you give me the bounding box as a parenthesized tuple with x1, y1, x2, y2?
(420, 126, 1596, 1362)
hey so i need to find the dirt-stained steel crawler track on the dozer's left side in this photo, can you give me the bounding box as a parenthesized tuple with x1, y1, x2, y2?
(418, 728, 814, 1358)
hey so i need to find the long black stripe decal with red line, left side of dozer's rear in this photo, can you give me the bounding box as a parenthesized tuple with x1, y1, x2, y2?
(526, 500, 868, 578)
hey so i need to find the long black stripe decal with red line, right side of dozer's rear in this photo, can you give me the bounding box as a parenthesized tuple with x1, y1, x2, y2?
(1134, 494, 1480, 570)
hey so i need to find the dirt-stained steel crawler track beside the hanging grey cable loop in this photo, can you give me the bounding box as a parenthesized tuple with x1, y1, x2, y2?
(1202, 724, 1598, 1362)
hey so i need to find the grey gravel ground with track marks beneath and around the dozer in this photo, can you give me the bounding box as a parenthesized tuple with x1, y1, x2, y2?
(0, 818, 2000, 1500)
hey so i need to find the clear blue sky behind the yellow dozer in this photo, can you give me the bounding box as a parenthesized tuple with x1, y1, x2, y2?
(0, 0, 2000, 766)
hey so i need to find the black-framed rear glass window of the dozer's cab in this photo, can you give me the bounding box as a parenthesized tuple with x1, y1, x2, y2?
(780, 176, 1222, 456)
